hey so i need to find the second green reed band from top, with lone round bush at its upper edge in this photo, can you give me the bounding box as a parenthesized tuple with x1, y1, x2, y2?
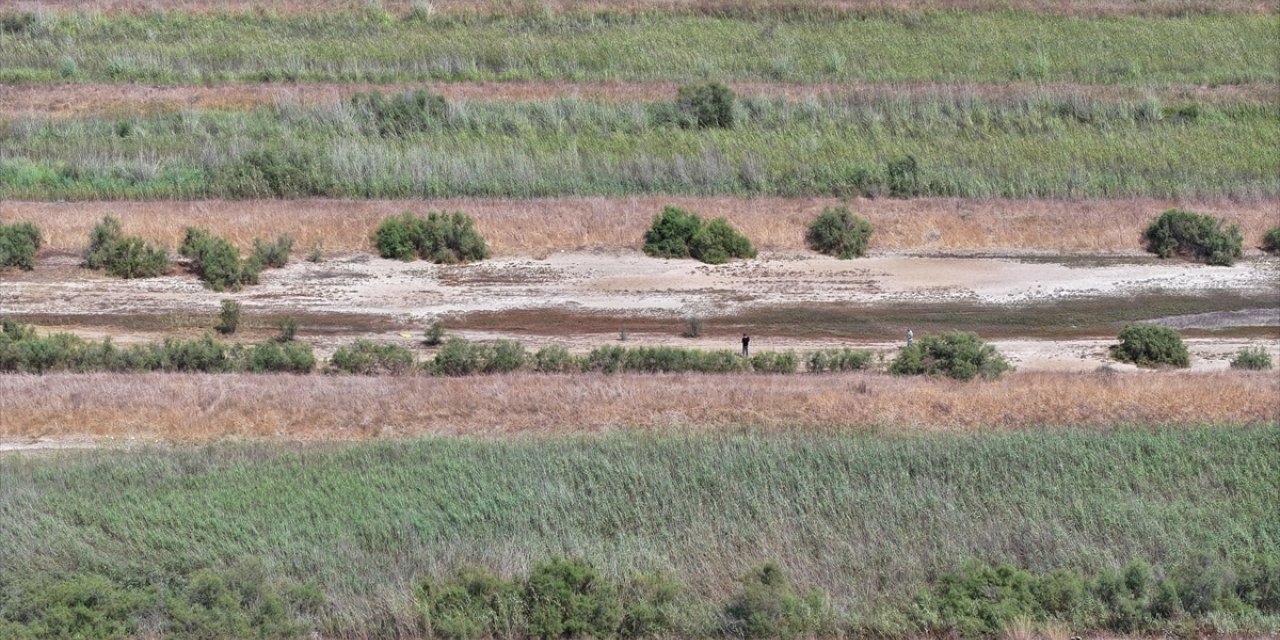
(0, 90, 1280, 200)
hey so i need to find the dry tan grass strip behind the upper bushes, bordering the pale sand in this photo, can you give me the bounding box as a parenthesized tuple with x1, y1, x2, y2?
(0, 196, 1280, 256)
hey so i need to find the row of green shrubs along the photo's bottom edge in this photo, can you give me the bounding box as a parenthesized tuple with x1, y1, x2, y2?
(0, 556, 1280, 640)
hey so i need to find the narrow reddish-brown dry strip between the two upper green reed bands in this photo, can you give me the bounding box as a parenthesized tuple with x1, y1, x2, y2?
(0, 81, 1280, 118)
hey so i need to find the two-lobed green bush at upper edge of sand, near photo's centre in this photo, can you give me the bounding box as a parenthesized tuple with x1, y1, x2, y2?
(644, 206, 755, 265)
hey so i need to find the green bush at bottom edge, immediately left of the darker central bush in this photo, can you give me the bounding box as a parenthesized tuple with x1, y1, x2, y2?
(419, 567, 525, 640)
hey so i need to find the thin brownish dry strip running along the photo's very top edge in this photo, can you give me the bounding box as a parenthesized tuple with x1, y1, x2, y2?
(12, 0, 1275, 17)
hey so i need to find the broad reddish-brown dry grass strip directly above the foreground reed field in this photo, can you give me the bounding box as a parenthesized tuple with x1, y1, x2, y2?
(0, 372, 1280, 442)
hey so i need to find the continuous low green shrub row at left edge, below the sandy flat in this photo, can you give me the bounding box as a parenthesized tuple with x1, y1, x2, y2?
(0, 317, 316, 374)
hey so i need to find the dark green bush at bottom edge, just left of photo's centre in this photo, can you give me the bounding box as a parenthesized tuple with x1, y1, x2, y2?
(525, 558, 622, 637)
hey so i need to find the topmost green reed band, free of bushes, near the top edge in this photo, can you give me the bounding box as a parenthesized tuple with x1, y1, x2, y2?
(0, 10, 1280, 86)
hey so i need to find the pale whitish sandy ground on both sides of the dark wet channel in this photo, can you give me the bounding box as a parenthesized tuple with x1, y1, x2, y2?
(0, 251, 1280, 370)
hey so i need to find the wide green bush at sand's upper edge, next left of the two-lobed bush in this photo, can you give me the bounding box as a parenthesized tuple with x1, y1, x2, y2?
(374, 211, 489, 264)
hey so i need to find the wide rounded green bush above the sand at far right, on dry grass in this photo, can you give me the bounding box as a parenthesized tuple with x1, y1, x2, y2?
(1143, 209, 1244, 266)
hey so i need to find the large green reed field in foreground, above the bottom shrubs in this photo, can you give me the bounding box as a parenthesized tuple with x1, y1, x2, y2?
(0, 425, 1280, 634)
